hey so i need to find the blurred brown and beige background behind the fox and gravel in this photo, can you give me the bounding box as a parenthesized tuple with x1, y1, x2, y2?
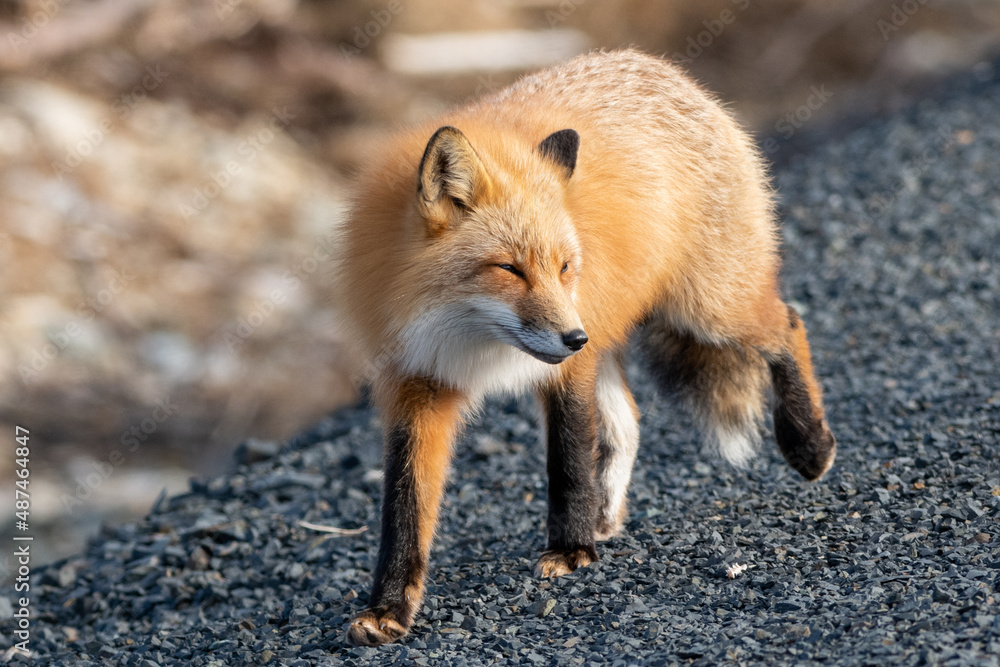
(0, 0, 1000, 562)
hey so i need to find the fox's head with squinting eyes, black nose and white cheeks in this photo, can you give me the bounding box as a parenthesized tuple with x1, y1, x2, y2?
(398, 126, 587, 364)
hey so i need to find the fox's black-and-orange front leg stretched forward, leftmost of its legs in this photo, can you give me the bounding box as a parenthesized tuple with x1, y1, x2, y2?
(347, 380, 462, 646)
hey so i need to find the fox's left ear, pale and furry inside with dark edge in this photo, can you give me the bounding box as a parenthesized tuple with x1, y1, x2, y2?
(417, 125, 490, 236)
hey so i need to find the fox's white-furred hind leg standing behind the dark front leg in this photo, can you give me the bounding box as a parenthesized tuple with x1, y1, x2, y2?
(594, 352, 639, 540)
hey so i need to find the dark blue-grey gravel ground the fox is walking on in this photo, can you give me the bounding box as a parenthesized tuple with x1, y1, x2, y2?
(0, 61, 1000, 667)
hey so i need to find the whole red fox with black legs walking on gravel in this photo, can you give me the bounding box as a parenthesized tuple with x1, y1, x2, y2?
(335, 50, 836, 645)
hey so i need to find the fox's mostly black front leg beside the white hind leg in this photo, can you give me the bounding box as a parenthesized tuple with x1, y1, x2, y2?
(535, 373, 598, 577)
